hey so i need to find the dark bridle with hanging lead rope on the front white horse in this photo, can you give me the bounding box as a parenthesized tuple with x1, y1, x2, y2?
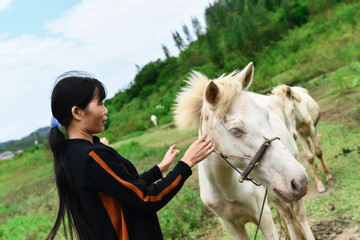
(199, 114, 280, 239)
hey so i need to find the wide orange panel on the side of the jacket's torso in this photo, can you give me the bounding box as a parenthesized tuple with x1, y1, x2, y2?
(99, 192, 129, 240)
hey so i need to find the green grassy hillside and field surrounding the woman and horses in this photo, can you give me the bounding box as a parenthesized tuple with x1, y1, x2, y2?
(0, 0, 360, 240)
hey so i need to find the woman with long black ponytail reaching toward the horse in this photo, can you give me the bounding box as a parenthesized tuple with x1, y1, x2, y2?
(47, 72, 214, 240)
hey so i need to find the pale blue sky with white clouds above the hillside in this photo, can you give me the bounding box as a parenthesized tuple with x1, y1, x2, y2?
(0, 0, 213, 142)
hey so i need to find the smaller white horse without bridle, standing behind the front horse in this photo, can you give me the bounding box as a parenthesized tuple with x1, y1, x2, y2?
(272, 85, 333, 193)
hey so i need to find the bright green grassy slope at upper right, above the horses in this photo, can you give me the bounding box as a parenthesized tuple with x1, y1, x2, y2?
(254, 2, 360, 91)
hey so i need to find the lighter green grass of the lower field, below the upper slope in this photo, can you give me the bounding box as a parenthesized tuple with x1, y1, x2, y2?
(0, 70, 360, 240)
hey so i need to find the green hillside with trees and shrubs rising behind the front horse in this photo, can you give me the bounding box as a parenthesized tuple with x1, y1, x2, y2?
(98, 0, 360, 142)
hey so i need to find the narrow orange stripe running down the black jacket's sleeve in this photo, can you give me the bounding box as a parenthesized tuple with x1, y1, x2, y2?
(89, 151, 182, 202)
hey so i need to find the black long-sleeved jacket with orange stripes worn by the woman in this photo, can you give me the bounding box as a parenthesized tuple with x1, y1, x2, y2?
(67, 137, 192, 240)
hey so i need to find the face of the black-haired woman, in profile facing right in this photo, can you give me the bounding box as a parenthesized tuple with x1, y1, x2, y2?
(83, 88, 108, 134)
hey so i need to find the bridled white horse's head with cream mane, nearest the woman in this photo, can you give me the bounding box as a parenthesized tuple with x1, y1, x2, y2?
(175, 63, 308, 202)
